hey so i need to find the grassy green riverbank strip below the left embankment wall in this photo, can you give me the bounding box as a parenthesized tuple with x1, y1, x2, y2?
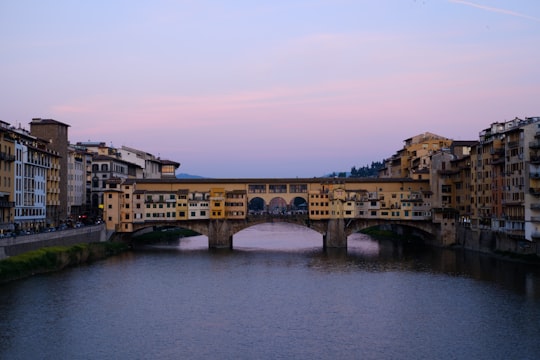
(0, 242, 129, 284)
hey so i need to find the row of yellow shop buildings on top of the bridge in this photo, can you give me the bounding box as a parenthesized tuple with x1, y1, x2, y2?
(104, 178, 431, 232)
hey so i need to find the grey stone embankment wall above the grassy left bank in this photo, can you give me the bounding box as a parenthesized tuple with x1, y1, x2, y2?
(0, 224, 107, 259)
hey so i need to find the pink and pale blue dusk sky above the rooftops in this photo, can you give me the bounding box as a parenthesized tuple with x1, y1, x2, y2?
(0, 0, 540, 178)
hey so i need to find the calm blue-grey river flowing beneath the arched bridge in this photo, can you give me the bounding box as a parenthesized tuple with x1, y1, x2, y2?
(0, 224, 540, 360)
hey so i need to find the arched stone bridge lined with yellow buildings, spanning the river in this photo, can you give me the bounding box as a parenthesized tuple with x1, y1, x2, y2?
(103, 178, 455, 248)
